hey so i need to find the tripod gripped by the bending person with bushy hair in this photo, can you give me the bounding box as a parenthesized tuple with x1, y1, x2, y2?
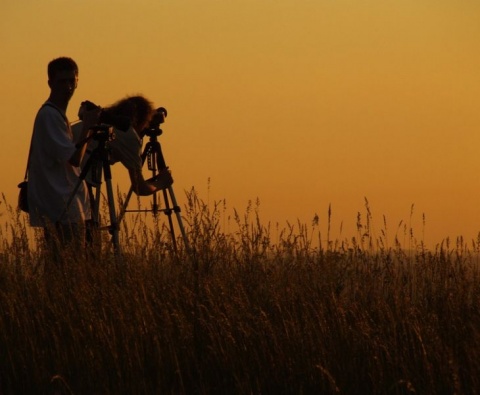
(118, 116, 190, 252)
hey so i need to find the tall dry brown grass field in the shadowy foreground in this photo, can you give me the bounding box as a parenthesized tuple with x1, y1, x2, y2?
(0, 191, 480, 395)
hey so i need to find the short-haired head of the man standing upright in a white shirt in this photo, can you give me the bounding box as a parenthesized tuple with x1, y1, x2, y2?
(48, 57, 78, 103)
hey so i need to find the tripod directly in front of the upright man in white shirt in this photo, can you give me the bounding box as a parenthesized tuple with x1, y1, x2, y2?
(61, 125, 120, 257)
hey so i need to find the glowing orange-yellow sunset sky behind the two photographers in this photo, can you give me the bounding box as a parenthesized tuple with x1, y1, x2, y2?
(0, 0, 480, 247)
